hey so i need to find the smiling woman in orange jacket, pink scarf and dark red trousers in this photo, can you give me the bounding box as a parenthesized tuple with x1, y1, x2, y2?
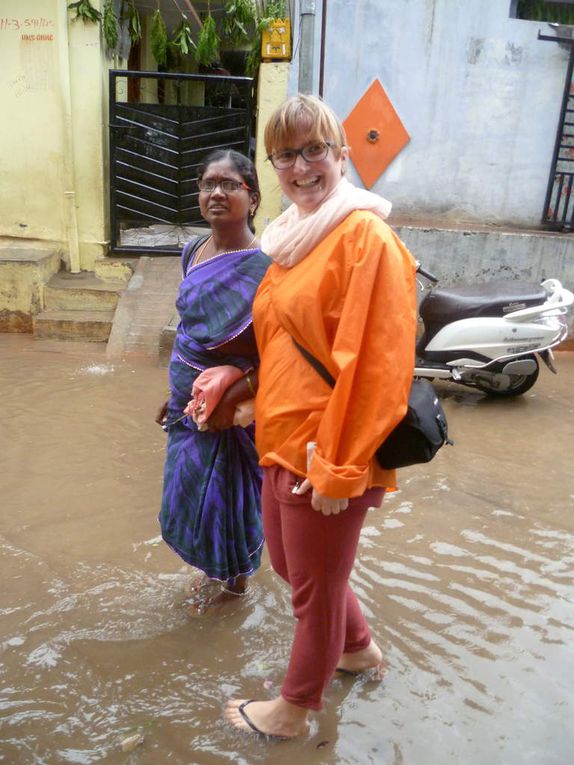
(225, 95, 416, 738)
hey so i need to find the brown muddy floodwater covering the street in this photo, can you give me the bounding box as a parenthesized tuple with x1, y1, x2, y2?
(0, 335, 574, 765)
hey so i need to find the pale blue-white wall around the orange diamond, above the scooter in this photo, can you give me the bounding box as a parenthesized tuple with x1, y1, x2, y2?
(289, 0, 568, 226)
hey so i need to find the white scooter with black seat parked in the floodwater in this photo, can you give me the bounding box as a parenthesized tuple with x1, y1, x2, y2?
(415, 264, 574, 397)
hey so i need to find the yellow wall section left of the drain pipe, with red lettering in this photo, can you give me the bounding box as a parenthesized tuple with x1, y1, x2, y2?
(0, 0, 64, 241)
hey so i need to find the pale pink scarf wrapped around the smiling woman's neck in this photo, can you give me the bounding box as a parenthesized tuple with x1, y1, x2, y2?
(261, 178, 391, 268)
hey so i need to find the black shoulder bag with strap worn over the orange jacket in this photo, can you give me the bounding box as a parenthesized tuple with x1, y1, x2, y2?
(291, 337, 453, 470)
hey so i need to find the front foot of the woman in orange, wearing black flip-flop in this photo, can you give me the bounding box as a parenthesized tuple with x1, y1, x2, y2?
(223, 696, 309, 739)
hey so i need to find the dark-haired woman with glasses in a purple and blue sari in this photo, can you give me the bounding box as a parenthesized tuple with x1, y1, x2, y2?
(157, 150, 270, 608)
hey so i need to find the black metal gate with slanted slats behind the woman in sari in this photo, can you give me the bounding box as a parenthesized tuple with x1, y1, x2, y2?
(109, 69, 253, 255)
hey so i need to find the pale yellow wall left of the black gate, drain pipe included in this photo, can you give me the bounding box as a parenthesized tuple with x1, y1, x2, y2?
(0, 0, 113, 270)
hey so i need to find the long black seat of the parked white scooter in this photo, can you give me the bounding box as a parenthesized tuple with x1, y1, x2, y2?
(419, 279, 547, 324)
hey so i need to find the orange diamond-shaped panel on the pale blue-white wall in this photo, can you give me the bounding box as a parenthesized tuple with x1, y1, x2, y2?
(343, 80, 410, 189)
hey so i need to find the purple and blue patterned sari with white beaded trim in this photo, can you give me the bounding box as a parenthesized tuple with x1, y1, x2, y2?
(159, 242, 270, 581)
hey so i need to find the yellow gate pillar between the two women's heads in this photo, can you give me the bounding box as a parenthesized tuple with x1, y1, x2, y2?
(255, 61, 289, 234)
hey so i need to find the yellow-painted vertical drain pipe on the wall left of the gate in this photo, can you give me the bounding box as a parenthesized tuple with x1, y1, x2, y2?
(58, 3, 81, 274)
